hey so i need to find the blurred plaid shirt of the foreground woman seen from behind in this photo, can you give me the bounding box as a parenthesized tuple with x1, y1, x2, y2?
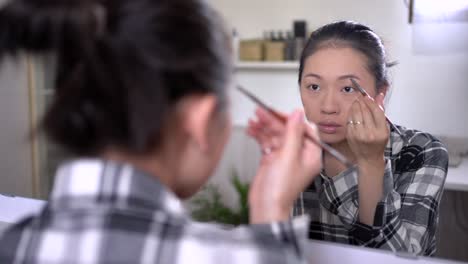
(0, 160, 309, 264)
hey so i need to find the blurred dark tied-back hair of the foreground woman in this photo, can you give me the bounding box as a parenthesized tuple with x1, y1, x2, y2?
(0, 0, 232, 155)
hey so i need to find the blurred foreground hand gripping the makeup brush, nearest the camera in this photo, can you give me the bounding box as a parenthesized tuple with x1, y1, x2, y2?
(248, 109, 322, 223)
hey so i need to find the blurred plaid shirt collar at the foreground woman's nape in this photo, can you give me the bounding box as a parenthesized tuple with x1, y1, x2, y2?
(49, 159, 186, 215)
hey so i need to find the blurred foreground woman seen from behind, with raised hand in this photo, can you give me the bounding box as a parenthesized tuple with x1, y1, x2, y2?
(0, 0, 321, 264)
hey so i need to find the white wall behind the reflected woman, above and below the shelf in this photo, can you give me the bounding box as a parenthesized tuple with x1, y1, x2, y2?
(209, 0, 468, 136)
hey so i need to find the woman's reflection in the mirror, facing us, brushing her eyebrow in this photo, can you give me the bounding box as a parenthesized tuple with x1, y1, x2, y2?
(249, 21, 448, 256)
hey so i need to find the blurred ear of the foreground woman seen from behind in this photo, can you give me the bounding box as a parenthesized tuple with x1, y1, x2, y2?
(182, 95, 218, 152)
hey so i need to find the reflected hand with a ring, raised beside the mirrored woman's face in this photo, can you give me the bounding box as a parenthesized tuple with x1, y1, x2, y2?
(347, 93, 390, 164)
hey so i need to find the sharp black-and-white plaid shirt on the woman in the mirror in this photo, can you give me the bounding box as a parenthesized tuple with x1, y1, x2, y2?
(294, 125, 448, 256)
